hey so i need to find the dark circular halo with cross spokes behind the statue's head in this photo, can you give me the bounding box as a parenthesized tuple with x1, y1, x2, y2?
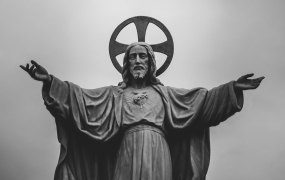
(109, 16, 174, 76)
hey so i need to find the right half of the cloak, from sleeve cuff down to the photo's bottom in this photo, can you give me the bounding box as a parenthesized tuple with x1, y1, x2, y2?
(154, 81, 243, 180)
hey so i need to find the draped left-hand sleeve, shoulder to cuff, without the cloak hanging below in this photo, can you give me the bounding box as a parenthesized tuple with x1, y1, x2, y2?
(43, 77, 119, 141)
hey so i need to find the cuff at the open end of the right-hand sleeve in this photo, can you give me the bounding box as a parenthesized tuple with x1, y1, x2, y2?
(228, 81, 244, 112)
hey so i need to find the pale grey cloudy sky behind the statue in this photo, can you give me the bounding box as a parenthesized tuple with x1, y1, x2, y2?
(0, 0, 285, 180)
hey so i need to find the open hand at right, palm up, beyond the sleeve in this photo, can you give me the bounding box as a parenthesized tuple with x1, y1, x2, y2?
(234, 73, 265, 90)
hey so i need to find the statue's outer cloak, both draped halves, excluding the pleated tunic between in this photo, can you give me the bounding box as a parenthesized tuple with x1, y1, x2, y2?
(43, 77, 243, 180)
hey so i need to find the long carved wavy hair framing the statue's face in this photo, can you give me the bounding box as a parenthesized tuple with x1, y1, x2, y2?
(119, 42, 163, 89)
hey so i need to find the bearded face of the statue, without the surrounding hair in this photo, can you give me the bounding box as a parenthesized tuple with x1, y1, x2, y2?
(129, 45, 148, 79)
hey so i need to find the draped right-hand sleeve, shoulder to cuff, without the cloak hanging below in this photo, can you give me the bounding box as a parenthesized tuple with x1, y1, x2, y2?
(155, 81, 243, 129)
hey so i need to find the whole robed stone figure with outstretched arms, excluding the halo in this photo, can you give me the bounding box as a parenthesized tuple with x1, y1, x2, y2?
(20, 16, 264, 180)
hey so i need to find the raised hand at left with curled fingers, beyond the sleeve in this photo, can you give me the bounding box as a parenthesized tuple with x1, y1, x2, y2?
(20, 60, 51, 83)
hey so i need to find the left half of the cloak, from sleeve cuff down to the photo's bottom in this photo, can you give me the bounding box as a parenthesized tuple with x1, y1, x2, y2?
(42, 76, 121, 180)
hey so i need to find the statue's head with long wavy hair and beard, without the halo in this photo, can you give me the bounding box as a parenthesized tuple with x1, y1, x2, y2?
(119, 42, 162, 88)
